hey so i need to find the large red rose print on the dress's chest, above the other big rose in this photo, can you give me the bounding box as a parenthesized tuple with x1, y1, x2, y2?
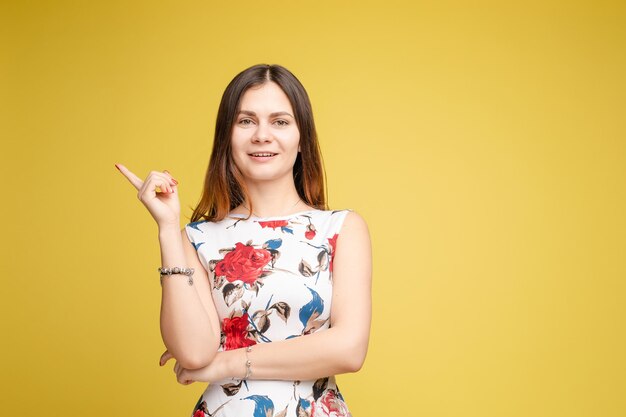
(215, 242, 272, 284)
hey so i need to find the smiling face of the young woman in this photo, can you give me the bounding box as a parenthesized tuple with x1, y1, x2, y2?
(231, 81, 300, 182)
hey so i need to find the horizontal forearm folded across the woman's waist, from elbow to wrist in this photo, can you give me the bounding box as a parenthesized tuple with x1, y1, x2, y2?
(223, 328, 368, 380)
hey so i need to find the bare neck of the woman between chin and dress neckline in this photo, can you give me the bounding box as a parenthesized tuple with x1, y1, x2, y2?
(237, 178, 309, 217)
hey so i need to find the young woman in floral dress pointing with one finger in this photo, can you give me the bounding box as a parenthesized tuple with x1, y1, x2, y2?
(116, 65, 371, 417)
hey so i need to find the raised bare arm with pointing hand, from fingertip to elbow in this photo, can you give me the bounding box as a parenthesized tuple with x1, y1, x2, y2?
(115, 164, 220, 369)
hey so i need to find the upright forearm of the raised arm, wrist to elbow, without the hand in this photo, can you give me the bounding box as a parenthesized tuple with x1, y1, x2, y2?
(159, 226, 219, 369)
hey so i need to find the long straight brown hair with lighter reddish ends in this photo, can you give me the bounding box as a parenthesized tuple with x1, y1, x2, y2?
(191, 64, 327, 222)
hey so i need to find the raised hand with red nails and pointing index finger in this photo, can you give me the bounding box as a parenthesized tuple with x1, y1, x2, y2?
(115, 164, 180, 228)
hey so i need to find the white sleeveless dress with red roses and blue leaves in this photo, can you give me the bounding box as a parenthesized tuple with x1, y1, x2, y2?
(185, 210, 351, 417)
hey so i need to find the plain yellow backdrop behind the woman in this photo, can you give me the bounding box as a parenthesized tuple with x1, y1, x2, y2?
(0, 0, 626, 417)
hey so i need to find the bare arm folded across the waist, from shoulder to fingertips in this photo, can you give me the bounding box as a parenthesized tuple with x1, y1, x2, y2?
(174, 213, 372, 383)
